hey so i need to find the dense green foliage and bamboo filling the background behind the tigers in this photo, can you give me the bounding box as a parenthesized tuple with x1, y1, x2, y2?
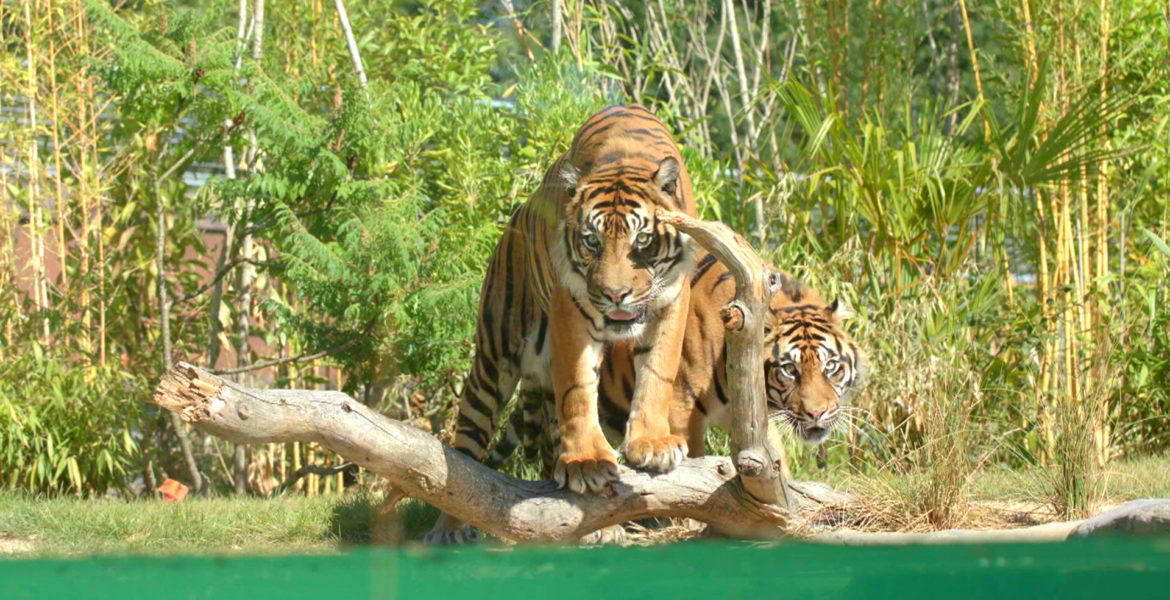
(0, 0, 1170, 500)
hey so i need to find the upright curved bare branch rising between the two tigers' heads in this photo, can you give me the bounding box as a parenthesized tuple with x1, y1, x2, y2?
(658, 212, 791, 506)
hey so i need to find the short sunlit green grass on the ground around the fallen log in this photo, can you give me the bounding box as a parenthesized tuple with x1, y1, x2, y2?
(0, 456, 1170, 557)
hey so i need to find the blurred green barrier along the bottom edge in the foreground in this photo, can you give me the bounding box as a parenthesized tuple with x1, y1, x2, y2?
(0, 538, 1170, 600)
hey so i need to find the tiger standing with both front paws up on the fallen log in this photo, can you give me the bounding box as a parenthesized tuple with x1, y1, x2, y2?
(427, 105, 695, 543)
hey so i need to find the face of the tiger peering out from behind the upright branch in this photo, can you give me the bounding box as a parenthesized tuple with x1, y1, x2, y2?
(764, 301, 861, 444)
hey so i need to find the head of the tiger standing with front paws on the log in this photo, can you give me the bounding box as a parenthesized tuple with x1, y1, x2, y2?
(563, 157, 689, 339)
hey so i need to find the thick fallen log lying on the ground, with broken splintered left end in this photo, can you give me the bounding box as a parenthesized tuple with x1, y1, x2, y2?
(153, 363, 820, 542)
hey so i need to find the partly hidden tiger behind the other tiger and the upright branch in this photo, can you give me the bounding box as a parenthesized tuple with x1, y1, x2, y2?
(507, 253, 862, 474)
